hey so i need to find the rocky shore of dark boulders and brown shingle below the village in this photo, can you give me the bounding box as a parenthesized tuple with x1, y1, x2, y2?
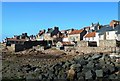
(2, 47, 120, 81)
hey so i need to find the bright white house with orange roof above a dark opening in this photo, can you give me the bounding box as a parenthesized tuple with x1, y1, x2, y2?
(83, 32, 99, 46)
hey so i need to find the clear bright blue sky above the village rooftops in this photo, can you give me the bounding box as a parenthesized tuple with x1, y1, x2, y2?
(0, 2, 118, 40)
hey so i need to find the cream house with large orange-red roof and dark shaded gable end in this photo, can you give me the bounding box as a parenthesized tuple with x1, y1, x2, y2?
(68, 29, 87, 42)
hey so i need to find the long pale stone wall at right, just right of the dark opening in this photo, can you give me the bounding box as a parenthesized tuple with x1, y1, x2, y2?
(99, 40, 116, 47)
